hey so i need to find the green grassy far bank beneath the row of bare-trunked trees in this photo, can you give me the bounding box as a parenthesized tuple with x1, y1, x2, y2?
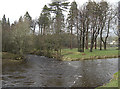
(62, 48, 118, 61)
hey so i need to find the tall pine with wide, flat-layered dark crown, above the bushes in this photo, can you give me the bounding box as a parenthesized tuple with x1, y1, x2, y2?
(49, 0, 69, 34)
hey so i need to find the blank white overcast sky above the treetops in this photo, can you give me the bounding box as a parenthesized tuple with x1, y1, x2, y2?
(0, 0, 119, 22)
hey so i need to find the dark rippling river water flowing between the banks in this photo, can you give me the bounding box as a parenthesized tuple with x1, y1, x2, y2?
(2, 55, 118, 87)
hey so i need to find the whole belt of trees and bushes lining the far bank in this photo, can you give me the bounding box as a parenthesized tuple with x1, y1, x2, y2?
(1, 0, 118, 58)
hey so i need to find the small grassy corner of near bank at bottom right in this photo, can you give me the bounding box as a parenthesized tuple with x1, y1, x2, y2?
(96, 71, 120, 89)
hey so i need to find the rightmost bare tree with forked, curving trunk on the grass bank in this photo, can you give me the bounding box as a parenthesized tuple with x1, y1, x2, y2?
(100, 1, 116, 50)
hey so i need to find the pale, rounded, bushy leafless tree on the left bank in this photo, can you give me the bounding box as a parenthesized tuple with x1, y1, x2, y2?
(11, 18, 31, 55)
